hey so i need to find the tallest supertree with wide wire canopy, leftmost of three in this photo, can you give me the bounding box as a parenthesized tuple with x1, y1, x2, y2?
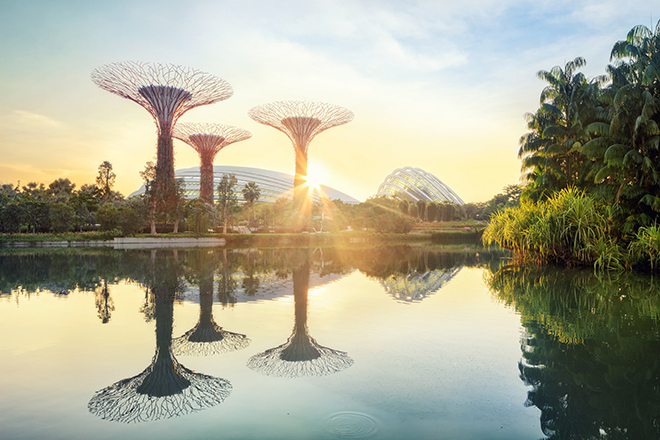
(92, 61, 234, 206)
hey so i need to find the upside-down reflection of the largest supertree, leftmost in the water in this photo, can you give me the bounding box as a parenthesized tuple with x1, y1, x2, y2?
(87, 253, 232, 423)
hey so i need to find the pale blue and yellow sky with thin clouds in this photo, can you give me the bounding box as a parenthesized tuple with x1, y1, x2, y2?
(0, 0, 660, 202)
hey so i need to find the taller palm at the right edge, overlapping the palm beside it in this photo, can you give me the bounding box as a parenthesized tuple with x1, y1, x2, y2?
(584, 22, 660, 232)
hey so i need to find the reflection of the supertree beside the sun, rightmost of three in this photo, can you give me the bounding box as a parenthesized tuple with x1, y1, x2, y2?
(247, 254, 353, 377)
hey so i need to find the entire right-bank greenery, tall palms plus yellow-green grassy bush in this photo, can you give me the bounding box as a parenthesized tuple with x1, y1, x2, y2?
(484, 21, 660, 269)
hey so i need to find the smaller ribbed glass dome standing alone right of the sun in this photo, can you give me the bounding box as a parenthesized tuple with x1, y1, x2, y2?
(376, 167, 465, 205)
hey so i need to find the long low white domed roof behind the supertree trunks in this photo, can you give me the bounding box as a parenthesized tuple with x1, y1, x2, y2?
(129, 165, 360, 203)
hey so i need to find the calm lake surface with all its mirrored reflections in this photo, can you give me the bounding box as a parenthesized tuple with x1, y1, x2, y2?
(0, 246, 660, 440)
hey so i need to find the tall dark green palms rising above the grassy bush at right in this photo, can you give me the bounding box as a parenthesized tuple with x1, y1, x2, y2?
(519, 22, 660, 232)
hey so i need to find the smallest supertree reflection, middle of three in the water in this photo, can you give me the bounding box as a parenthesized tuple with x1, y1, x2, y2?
(172, 276, 251, 356)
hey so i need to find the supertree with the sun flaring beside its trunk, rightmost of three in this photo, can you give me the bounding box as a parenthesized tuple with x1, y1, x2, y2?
(248, 101, 353, 229)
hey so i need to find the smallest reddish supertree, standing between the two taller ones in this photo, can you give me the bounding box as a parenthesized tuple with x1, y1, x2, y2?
(172, 123, 252, 204)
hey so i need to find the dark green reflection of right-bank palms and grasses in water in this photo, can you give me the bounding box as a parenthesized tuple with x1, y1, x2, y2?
(487, 267, 660, 439)
